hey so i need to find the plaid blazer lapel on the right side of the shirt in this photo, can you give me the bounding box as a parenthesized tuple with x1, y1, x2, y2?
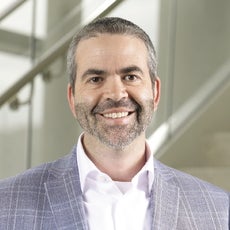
(150, 162, 179, 230)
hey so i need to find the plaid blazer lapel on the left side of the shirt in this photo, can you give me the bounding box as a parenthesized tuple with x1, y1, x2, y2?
(45, 154, 88, 230)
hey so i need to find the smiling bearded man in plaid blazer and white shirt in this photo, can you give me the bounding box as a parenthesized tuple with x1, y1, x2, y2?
(0, 18, 229, 230)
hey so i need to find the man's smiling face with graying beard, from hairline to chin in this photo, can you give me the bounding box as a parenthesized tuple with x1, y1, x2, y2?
(69, 34, 159, 149)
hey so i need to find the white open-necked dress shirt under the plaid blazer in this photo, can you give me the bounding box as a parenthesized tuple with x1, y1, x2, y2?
(77, 135, 154, 230)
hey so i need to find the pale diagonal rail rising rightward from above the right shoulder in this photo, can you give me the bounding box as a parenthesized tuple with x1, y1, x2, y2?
(148, 60, 230, 158)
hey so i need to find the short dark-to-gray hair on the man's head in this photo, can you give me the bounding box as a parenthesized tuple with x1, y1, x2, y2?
(67, 17, 157, 93)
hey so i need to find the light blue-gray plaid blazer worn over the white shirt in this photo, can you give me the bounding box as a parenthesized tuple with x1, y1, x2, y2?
(0, 148, 229, 230)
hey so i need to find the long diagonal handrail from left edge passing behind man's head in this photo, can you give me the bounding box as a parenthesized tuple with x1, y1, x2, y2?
(0, 0, 124, 108)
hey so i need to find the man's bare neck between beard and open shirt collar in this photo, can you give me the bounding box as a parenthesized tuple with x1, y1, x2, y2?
(83, 133, 146, 181)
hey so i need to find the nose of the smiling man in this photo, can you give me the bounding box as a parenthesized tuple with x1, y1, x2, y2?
(104, 76, 128, 101)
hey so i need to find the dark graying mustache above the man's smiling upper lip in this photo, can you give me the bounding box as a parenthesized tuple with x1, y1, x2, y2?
(92, 99, 141, 114)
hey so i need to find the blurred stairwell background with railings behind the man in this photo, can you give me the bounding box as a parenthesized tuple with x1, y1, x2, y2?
(0, 0, 230, 190)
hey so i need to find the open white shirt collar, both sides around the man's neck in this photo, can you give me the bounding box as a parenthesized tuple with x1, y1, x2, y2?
(76, 134, 154, 193)
